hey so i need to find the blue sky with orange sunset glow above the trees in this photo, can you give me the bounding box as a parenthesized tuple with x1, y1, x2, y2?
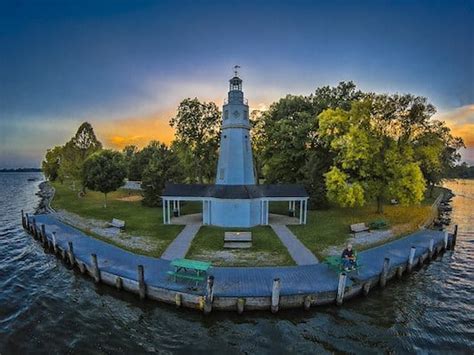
(0, 0, 474, 168)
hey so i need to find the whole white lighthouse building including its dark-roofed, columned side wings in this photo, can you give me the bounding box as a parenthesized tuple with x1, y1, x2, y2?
(162, 71, 309, 227)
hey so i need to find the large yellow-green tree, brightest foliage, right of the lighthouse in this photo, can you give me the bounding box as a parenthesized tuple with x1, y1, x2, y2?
(319, 98, 425, 213)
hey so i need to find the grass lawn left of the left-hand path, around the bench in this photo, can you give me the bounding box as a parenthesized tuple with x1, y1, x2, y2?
(52, 183, 183, 257)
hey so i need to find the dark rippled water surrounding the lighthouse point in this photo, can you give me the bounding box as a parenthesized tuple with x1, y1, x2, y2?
(0, 173, 474, 354)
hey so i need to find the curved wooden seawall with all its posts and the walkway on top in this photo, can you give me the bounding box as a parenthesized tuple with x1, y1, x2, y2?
(22, 213, 457, 313)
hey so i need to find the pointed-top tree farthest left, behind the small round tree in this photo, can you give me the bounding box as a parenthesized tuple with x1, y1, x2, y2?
(59, 122, 102, 192)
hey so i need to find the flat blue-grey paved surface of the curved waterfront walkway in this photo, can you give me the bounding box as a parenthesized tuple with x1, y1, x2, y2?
(30, 214, 444, 297)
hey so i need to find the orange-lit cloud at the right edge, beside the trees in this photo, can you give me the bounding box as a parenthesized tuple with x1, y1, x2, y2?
(434, 104, 474, 147)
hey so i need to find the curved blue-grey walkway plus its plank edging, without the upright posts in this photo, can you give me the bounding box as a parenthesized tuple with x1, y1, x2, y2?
(25, 215, 452, 310)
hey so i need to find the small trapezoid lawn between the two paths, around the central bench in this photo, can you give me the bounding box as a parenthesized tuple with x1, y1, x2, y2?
(186, 226, 295, 266)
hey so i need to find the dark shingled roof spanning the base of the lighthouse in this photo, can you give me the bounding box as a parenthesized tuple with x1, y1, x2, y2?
(162, 184, 308, 199)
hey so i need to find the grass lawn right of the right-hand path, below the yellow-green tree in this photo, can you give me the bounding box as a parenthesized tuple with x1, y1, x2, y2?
(286, 189, 442, 259)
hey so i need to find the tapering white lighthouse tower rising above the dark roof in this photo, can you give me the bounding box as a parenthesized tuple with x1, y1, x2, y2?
(216, 66, 255, 185)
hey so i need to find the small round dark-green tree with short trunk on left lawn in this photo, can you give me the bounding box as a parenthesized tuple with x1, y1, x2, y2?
(82, 149, 127, 208)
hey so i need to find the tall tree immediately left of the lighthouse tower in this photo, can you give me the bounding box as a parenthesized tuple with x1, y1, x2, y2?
(170, 98, 221, 183)
